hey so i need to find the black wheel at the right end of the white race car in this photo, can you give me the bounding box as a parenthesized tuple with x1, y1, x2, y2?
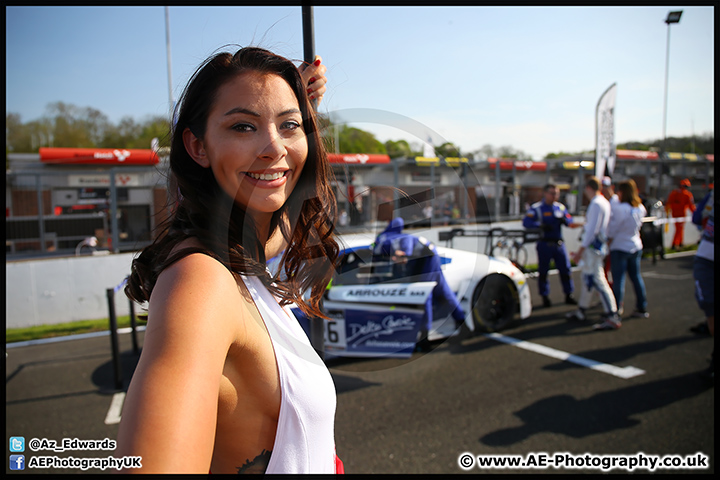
(472, 274, 518, 332)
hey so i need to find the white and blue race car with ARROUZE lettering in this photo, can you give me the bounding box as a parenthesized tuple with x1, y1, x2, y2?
(293, 231, 532, 358)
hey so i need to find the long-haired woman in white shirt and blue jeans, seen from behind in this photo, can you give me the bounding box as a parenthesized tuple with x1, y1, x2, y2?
(608, 179, 650, 318)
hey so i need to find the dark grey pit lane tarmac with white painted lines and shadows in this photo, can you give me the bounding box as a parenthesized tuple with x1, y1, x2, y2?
(6, 256, 714, 473)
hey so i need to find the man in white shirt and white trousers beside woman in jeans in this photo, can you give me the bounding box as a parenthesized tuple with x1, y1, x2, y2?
(567, 177, 621, 330)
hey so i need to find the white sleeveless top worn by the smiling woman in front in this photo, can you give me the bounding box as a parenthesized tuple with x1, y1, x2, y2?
(242, 277, 336, 474)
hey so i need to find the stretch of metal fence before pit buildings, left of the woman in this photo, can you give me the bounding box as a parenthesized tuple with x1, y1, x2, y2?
(5, 167, 166, 259)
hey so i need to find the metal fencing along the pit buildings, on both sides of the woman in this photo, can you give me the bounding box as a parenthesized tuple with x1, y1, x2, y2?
(5, 158, 714, 260)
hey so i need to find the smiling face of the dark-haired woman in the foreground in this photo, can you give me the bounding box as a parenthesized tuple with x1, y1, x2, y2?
(183, 72, 308, 220)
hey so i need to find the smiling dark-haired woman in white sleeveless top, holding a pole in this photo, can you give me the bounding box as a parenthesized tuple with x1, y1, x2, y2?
(117, 48, 339, 473)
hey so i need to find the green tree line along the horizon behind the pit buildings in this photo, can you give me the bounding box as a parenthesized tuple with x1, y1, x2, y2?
(5, 102, 715, 165)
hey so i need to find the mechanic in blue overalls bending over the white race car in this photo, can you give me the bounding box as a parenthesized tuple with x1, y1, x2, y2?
(373, 217, 465, 345)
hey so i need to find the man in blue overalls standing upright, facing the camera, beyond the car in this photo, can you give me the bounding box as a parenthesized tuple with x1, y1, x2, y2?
(523, 183, 582, 307)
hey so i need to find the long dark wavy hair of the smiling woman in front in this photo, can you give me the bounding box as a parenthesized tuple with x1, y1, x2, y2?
(125, 47, 338, 317)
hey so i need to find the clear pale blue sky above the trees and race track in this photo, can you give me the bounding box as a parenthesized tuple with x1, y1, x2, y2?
(6, 6, 715, 159)
